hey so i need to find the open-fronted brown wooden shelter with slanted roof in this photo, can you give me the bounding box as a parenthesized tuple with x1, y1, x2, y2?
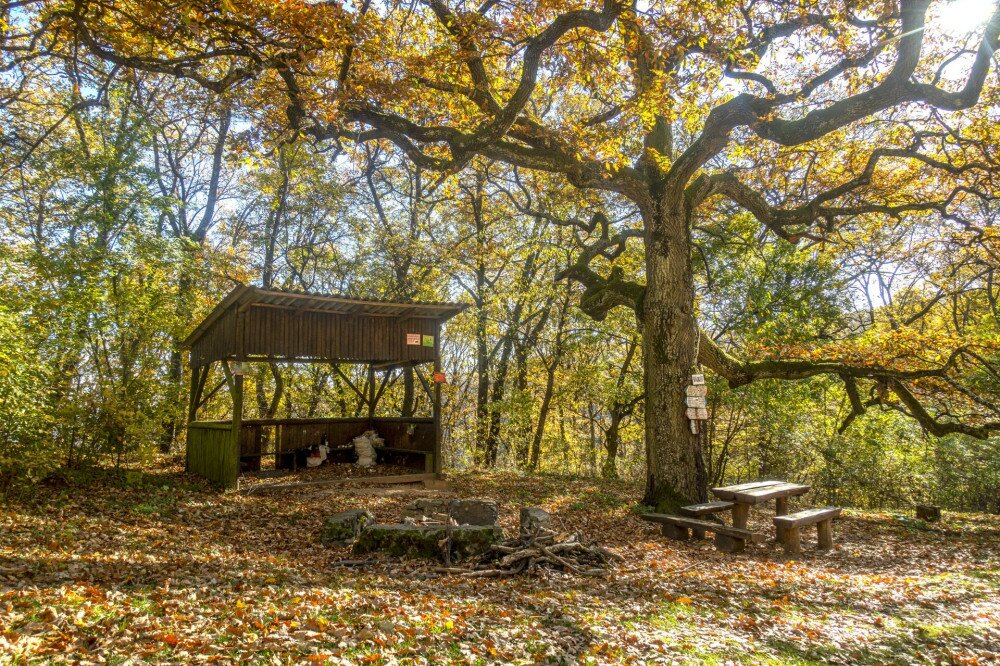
(184, 286, 467, 487)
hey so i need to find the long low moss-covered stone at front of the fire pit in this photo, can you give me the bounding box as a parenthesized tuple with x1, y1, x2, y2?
(354, 524, 503, 562)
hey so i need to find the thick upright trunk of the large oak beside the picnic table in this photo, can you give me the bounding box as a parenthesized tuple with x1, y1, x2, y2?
(642, 202, 706, 512)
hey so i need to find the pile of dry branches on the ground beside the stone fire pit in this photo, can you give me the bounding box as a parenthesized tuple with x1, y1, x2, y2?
(437, 528, 625, 578)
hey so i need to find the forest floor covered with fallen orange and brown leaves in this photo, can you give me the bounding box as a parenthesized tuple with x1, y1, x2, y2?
(0, 465, 1000, 664)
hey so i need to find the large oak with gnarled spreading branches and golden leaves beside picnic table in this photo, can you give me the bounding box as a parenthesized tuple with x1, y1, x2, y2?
(9, 0, 1000, 505)
